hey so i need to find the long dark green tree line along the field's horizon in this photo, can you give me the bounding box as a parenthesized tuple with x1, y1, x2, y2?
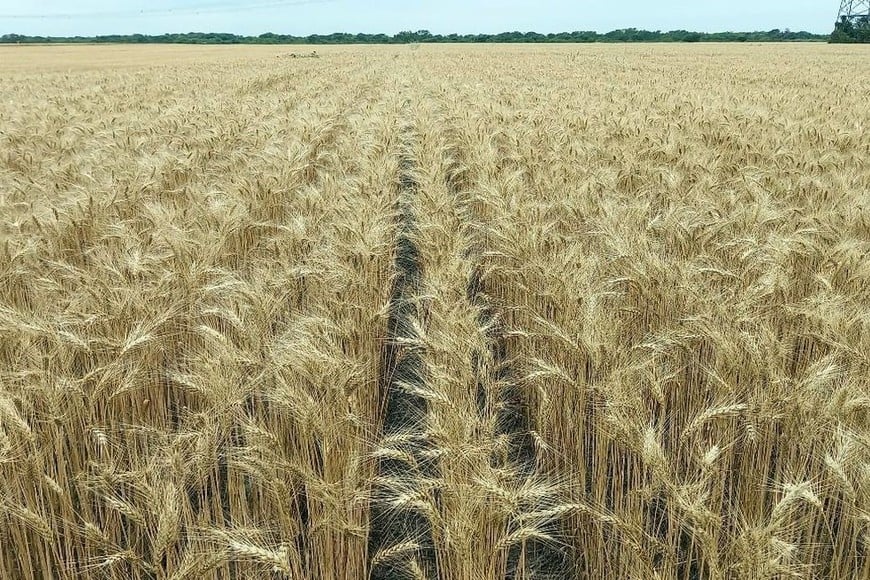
(0, 28, 829, 44)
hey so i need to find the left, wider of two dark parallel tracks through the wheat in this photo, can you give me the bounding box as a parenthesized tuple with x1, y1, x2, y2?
(369, 100, 438, 580)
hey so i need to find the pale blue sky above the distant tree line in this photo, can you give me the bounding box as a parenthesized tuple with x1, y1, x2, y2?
(0, 0, 839, 36)
